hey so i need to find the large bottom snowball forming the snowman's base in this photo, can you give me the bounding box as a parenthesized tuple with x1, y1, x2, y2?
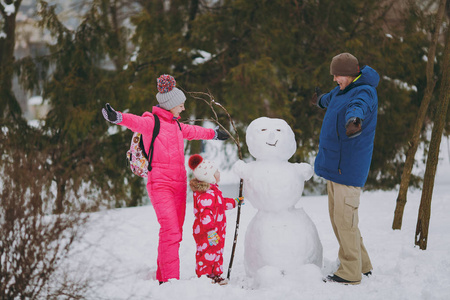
(244, 208, 323, 277)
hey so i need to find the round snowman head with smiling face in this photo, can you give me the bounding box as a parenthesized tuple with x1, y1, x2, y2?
(246, 117, 297, 161)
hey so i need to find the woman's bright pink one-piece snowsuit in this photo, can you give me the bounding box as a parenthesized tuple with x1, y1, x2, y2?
(119, 106, 215, 282)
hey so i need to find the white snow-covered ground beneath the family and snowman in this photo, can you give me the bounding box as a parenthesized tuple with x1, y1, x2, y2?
(69, 144, 450, 300)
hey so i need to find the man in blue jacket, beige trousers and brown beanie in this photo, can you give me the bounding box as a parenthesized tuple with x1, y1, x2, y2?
(311, 53, 380, 284)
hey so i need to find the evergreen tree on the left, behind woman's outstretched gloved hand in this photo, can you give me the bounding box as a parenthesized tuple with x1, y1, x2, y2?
(32, 1, 136, 213)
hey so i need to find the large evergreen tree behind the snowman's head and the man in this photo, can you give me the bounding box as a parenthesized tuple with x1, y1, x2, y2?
(186, 0, 442, 189)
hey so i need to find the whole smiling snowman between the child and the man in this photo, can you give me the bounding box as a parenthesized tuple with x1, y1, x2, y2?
(233, 117, 322, 277)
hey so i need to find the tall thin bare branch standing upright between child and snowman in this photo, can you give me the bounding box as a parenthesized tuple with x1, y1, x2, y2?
(185, 92, 245, 279)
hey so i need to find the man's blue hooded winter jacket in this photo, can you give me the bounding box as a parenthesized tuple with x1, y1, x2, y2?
(314, 66, 380, 187)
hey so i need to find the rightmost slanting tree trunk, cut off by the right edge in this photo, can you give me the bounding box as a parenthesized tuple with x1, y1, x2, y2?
(415, 24, 450, 250)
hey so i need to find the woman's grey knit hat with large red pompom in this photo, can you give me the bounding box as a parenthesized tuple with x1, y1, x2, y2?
(156, 74, 186, 110)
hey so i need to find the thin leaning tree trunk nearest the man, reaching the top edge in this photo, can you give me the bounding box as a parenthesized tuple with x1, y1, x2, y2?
(392, 0, 447, 230)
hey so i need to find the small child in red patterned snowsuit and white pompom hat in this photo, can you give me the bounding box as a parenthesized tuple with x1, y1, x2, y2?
(189, 154, 243, 285)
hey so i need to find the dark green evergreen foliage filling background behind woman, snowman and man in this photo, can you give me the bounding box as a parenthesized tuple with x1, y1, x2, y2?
(0, 0, 450, 212)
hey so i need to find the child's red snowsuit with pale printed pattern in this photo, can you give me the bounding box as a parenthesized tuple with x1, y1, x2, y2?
(191, 184, 237, 277)
